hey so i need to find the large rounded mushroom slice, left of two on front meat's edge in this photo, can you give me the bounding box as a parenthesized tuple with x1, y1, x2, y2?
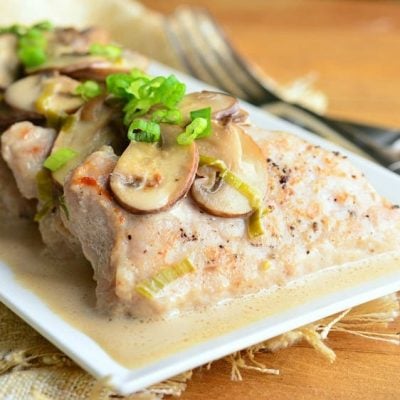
(110, 125, 199, 214)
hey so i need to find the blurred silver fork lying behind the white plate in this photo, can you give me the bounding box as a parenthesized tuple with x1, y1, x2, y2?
(165, 6, 400, 174)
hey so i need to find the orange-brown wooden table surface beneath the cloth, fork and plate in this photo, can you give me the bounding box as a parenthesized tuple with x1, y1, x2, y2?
(143, 0, 400, 400)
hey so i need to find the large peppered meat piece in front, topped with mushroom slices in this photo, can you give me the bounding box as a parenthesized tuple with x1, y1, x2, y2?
(64, 131, 400, 316)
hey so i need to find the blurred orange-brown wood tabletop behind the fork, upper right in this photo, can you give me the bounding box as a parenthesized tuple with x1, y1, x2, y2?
(142, 0, 400, 127)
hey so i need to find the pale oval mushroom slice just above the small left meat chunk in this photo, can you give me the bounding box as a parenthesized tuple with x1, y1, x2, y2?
(4, 74, 83, 115)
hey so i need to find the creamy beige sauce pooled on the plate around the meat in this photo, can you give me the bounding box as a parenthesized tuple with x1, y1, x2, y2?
(0, 220, 400, 368)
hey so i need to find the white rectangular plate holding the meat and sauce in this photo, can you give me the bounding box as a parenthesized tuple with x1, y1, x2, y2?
(0, 63, 400, 394)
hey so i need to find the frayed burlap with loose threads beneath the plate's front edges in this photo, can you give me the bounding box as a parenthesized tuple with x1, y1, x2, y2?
(0, 294, 400, 400)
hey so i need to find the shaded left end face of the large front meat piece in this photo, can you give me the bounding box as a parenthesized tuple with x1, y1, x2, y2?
(64, 147, 121, 309)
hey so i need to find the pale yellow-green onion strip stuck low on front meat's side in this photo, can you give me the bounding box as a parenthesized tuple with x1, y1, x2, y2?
(135, 258, 196, 300)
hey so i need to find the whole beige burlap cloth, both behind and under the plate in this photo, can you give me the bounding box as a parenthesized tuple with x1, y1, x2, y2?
(0, 0, 400, 400)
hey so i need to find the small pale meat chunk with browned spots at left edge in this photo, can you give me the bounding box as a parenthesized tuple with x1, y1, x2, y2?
(1, 121, 56, 199)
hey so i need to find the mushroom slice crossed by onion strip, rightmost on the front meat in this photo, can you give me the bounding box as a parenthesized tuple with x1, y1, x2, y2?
(191, 123, 267, 218)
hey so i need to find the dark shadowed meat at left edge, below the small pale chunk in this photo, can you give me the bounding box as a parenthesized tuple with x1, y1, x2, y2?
(0, 151, 36, 218)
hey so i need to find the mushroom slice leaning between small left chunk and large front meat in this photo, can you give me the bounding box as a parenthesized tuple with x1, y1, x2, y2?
(51, 97, 116, 185)
